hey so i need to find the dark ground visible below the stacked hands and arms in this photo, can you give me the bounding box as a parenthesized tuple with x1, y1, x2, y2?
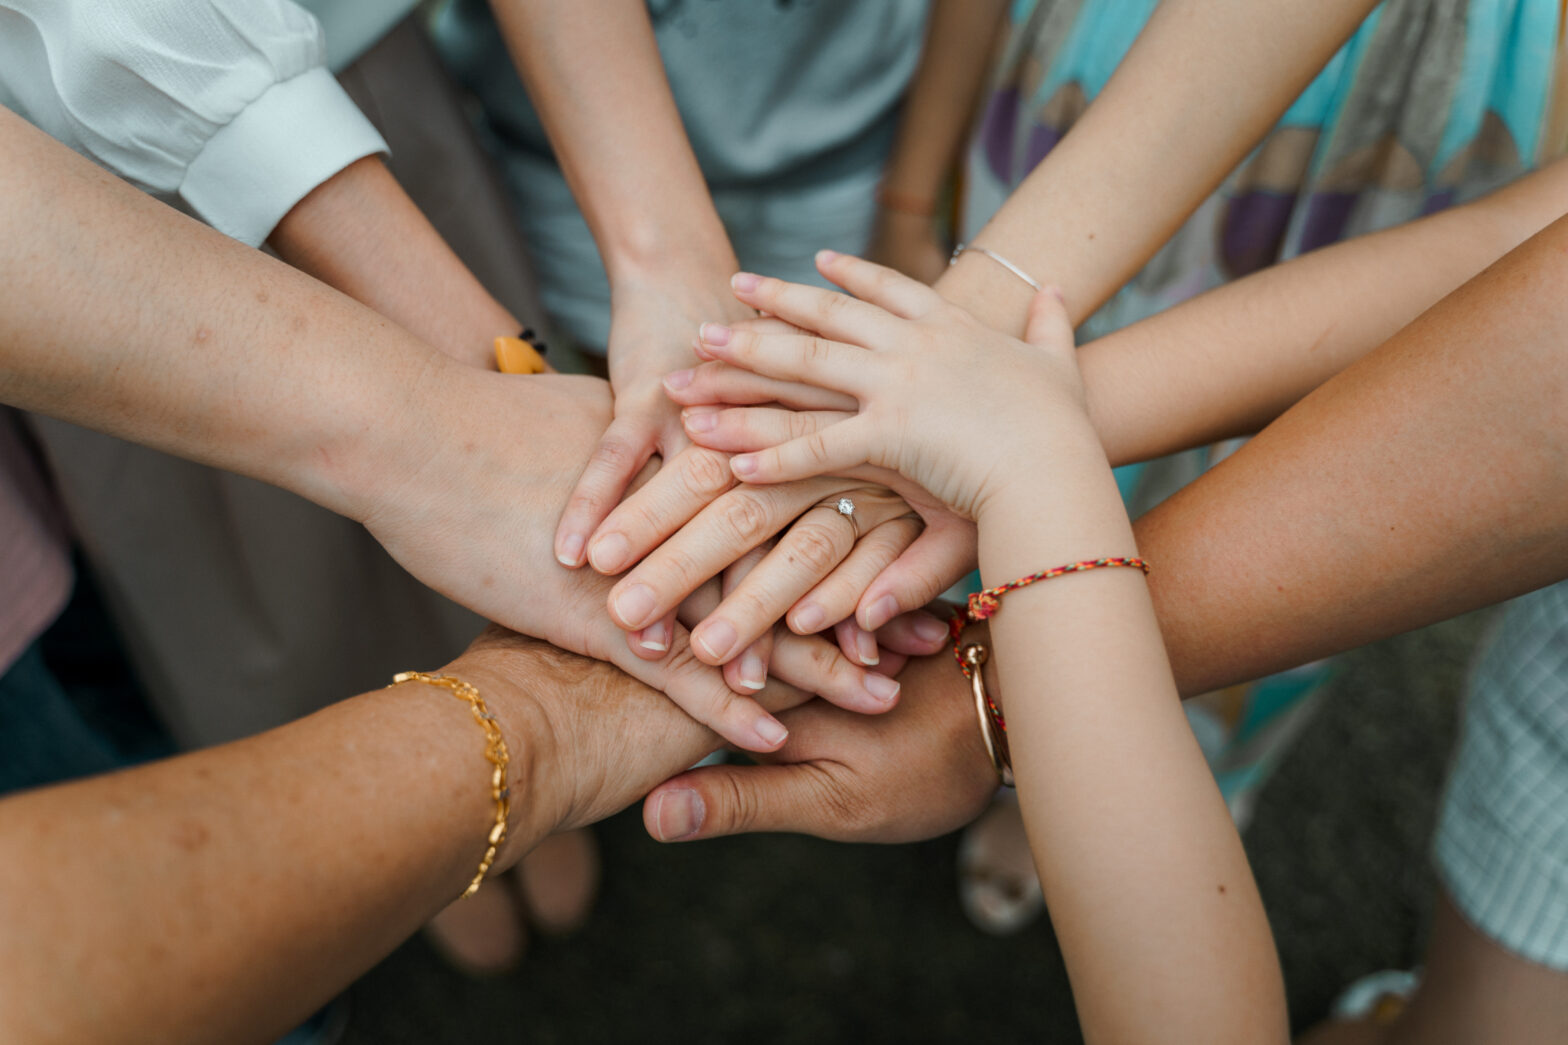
(345, 615, 1485, 1045)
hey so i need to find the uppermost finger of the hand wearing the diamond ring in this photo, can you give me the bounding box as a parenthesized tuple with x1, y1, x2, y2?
(588, 447, 735, 574)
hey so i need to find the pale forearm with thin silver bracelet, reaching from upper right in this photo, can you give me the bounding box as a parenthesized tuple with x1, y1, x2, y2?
(938, 0, 1374, 334)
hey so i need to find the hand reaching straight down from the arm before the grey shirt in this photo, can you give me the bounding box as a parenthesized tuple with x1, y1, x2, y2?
(555, 280, 753, 568)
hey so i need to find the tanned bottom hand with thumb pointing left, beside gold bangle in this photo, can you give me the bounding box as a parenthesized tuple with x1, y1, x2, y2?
(643, 640, 997, 843)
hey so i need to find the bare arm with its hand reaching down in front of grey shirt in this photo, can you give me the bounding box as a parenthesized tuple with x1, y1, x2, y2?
(491, 0, 745, 566)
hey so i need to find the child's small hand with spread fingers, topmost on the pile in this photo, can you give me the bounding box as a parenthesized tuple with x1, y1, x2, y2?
(698, 251, 1091, 519)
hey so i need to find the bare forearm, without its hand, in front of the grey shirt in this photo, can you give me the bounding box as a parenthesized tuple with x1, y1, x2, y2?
(491, 0, 735, 290)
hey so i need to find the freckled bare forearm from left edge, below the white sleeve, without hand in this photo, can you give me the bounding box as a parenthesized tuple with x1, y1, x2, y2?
(0, 111, 435, 518)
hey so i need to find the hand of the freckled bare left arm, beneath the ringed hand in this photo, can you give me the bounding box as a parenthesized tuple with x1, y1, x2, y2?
(350, 365, 872, 750)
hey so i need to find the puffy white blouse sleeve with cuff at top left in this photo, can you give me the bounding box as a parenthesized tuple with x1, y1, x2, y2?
(0, 0, 386, 246)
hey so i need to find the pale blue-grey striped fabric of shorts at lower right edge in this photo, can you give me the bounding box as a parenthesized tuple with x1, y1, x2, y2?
(1436, 581, 1568, 971)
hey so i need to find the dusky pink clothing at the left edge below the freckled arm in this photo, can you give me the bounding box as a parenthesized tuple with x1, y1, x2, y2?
(0, 408, 72, 675)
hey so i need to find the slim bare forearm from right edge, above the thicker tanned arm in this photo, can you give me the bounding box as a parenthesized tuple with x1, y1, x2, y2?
(1079, 162, 1568, 464)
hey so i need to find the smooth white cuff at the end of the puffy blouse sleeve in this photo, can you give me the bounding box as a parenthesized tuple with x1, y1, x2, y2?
(179, 69, 387, 246)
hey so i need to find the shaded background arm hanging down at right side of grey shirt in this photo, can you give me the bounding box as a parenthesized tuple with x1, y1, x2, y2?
(867, 0, 1007, 282)
